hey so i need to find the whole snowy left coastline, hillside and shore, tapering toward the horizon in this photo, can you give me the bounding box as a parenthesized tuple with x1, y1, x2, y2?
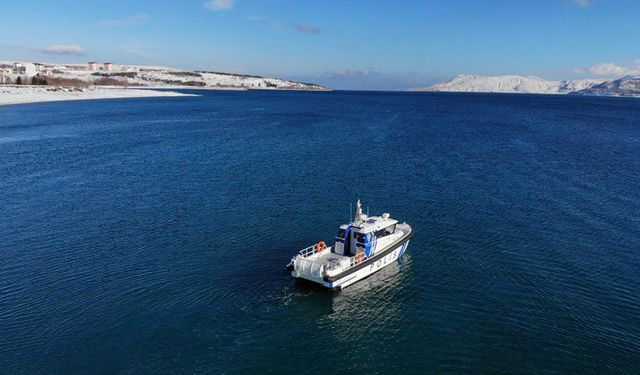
(0, 61, 329, 105)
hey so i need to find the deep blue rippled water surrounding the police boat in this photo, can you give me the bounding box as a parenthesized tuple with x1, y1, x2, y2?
(0, 91, 640, 375)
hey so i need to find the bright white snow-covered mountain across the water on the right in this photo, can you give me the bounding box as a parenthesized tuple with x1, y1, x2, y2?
(410, 74, 603, 94)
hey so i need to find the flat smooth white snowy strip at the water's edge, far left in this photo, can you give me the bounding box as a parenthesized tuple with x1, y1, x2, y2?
(0, 85, 192, 105)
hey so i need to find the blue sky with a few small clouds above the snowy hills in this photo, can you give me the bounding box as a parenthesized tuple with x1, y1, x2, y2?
(0, 0, 640, 90)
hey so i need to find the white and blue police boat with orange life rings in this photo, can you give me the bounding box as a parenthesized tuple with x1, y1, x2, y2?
(287, 199, 413, 290)
